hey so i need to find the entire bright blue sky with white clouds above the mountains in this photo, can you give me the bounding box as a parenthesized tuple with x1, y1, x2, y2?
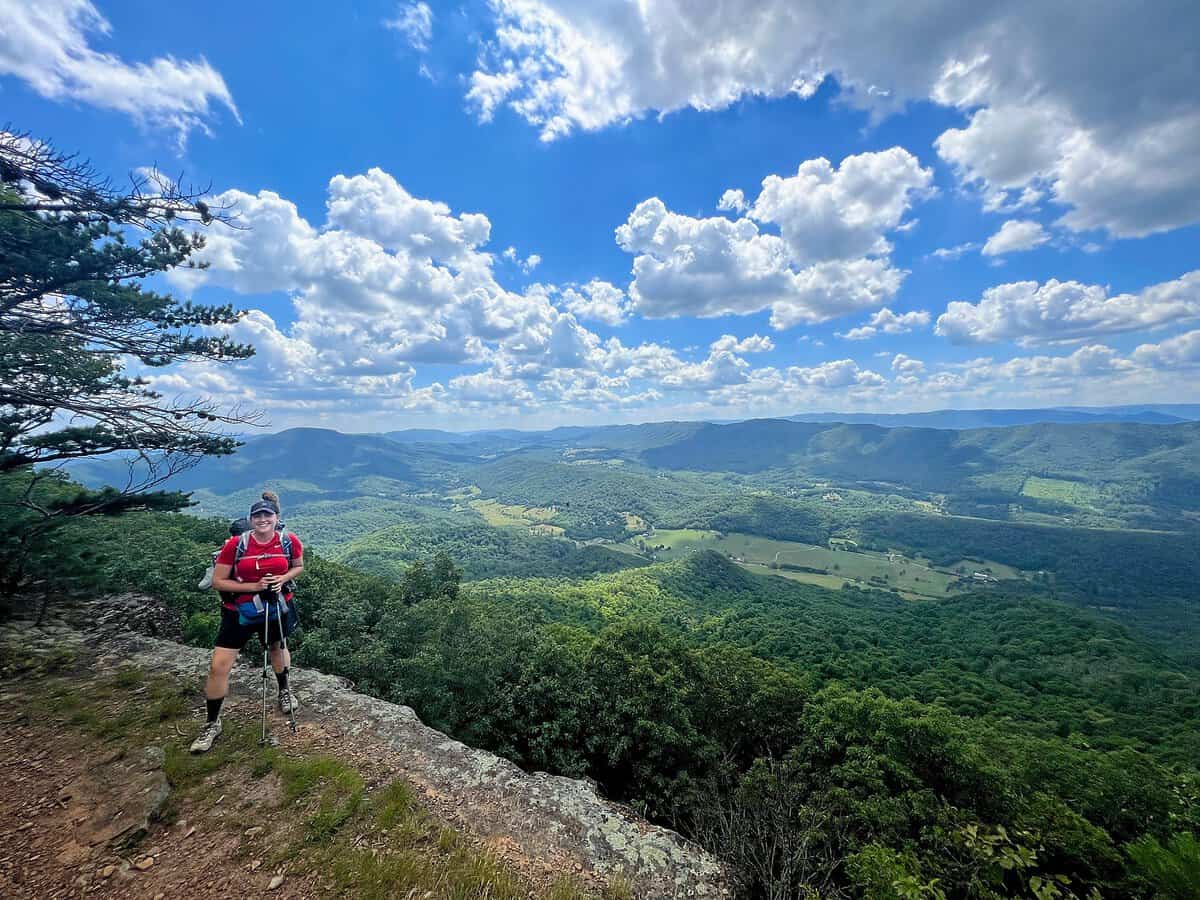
(0, 0, 1200, 431)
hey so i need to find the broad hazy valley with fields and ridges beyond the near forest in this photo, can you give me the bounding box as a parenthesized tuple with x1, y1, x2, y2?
(63, 420, 1200, 658)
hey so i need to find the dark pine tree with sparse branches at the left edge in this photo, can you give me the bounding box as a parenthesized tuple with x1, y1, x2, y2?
(0, 131, 253, 589)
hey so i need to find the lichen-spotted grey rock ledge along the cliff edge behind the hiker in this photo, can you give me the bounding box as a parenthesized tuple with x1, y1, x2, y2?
(0, 596, 731, 898)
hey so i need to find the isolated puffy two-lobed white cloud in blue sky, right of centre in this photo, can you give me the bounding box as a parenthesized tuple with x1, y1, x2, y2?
(617, 148, 932, 329)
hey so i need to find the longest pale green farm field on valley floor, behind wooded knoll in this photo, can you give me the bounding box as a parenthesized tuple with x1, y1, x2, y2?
(638, 528, 984, 596)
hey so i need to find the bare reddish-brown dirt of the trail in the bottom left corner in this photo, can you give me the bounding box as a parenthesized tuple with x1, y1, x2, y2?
(0, 710, 320, 900)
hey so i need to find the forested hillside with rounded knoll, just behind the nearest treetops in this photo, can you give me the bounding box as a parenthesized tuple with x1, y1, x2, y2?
(466, 551, 1200, 762)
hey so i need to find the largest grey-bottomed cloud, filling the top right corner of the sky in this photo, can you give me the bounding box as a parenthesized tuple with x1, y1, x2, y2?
(468, 0, 1200, 236)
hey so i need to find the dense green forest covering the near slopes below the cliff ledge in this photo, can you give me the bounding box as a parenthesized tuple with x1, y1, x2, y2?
(11, 496, 1200, 898)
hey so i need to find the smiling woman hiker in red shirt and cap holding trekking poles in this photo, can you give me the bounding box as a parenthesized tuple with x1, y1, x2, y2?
(192, 491, 304, 754)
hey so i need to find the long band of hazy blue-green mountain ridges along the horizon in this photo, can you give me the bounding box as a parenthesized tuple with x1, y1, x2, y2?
(73, 419, 1200, 527)
